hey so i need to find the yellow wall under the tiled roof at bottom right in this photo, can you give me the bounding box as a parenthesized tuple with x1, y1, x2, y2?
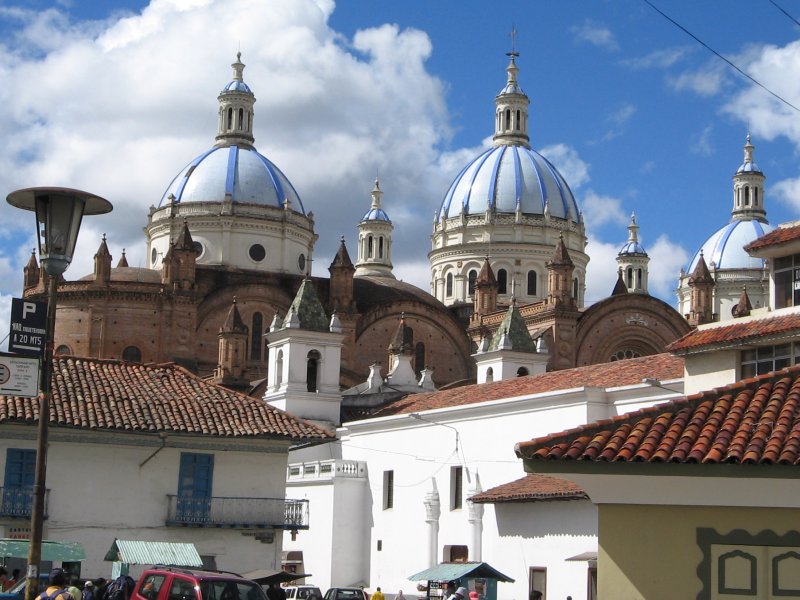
(597, 504, 800, 600)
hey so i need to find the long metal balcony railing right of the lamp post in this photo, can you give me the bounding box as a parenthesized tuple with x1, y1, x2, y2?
(167, 495, 308, 530)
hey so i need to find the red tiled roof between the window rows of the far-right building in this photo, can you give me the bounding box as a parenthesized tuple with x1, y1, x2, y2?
(667, 312, 800, 352)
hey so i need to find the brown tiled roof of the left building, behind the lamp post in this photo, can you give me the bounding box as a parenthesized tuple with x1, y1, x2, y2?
(0, 356, 332, 440)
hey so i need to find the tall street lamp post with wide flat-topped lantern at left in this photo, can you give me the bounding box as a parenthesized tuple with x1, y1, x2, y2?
(6, 187, 113, 600)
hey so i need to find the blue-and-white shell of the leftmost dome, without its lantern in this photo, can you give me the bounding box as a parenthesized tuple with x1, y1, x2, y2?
(159, 145, 305, 214)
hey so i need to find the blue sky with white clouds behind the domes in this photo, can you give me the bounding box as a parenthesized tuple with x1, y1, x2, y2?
(0, 0, 800, 348)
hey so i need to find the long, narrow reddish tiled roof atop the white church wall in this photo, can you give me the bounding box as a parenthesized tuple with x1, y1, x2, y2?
(373, 353, 683, 417)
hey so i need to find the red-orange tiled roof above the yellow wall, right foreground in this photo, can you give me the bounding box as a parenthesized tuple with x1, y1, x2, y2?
(516, 365, 800, 465)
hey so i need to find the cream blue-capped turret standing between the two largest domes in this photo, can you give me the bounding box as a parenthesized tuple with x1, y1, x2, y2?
(355, 178, 395, 279)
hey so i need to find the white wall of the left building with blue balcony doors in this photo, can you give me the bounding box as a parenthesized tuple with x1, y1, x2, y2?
(0, 427, 294, 577)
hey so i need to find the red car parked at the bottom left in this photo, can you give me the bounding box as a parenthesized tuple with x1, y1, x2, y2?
(131, 566, 266, 600)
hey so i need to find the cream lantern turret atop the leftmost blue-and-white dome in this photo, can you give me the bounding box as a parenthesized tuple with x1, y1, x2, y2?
(216, 52, 256, 146)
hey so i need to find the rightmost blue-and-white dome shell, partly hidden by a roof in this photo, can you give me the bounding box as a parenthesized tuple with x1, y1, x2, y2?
(687, 219, 774, 273)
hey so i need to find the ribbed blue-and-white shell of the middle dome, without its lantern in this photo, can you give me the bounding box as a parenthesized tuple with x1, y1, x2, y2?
(439, 145, 580, 223)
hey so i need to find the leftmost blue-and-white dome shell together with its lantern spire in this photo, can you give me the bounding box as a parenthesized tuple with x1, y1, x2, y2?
(159, 53, 305, 214)
